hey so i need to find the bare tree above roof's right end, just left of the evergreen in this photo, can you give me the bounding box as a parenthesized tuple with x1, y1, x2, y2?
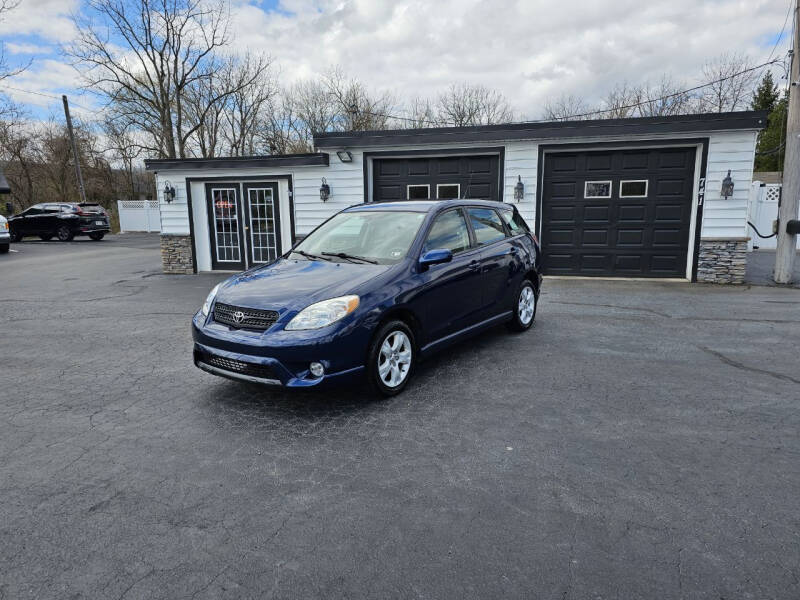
(698, 53, 758, 112)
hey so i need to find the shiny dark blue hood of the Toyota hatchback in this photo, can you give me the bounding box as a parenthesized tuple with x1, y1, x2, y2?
(217, 259, 392, 313)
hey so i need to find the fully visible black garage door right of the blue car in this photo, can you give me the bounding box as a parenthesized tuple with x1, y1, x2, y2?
(541, 148, 695, 277)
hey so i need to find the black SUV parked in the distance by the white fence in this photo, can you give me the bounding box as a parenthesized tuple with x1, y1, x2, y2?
(8, 202, 110, 242)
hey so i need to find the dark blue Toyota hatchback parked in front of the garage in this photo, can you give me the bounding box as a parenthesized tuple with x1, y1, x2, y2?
(193, 200, 542, 395)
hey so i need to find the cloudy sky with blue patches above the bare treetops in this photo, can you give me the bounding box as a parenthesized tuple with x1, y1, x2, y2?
(0, 0, 794, 118)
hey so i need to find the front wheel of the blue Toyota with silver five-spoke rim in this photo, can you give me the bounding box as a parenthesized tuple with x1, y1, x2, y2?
(367, 321, 417, 396)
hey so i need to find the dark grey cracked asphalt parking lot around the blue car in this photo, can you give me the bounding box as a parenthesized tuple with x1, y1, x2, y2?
(0, 234, 800, 599)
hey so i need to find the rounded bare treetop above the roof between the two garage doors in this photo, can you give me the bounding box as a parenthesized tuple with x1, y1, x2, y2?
(436, 83, 514, 127)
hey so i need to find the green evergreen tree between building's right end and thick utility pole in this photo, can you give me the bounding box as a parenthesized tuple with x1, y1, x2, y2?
(750, 71, 789, 171)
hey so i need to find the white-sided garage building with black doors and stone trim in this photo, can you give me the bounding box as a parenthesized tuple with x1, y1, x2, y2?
(146, 112, 766, 283)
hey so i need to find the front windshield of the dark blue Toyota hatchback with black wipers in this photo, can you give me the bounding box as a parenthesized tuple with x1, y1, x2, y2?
(292, 211, 425, 265)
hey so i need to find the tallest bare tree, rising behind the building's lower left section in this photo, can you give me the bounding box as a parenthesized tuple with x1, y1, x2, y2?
(67, 0, 232, 158)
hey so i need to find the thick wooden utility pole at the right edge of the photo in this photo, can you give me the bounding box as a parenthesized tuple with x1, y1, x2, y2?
(774, 0, 800, 283)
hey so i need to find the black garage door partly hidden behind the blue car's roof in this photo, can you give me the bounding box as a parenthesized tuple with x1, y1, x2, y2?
(372, 155, 500, 202)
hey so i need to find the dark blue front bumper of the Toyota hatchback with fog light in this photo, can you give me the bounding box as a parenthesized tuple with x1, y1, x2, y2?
(192, 312, 368, 388)
